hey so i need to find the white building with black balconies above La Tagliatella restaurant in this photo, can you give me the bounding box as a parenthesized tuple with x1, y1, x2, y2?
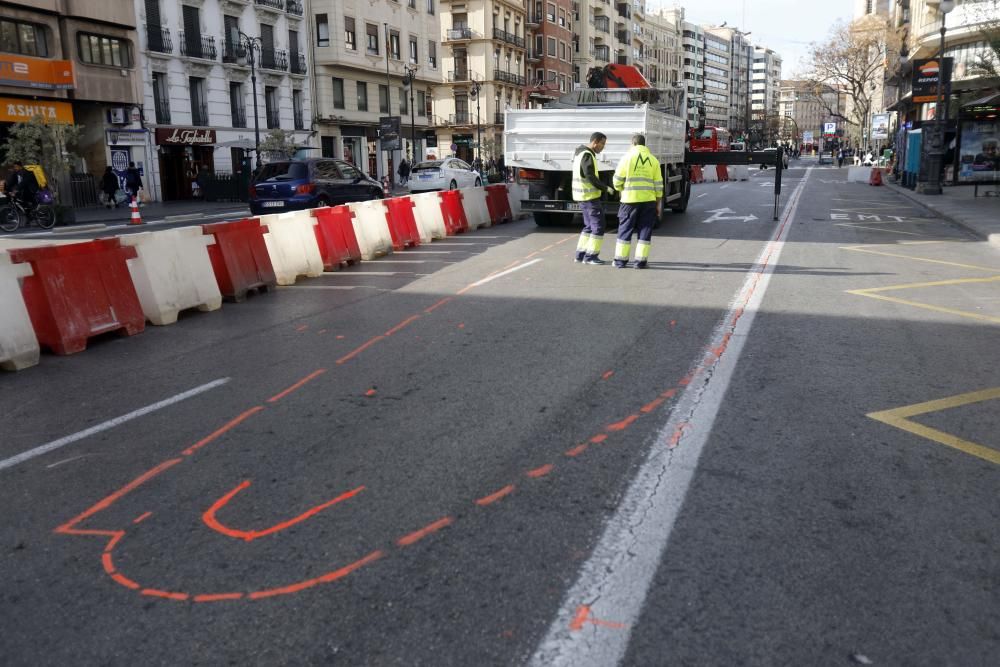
(135, 0, 312, 201)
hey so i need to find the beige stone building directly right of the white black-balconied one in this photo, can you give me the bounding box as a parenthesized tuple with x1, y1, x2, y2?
(312, 0, 438, 181)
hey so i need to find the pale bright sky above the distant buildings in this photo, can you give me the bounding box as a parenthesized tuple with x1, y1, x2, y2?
(647, 0, 854, 79)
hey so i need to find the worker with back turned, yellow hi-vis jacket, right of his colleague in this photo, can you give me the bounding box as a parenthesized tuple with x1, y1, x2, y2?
(612, 134, 663, 269)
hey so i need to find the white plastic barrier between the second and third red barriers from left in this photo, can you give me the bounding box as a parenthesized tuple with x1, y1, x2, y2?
(258, 211, 323, 285)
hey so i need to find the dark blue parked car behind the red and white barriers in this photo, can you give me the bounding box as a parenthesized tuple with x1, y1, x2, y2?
(250, 158, 385, 215)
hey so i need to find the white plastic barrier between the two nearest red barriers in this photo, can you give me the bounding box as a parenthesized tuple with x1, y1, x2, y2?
(118, 227, 222, 326)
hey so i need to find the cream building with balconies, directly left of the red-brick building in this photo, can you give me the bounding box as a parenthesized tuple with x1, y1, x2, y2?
(434, 0, 532, 161)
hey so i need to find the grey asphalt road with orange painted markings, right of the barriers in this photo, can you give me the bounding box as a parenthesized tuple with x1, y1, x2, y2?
(0, 166, 1000, 665)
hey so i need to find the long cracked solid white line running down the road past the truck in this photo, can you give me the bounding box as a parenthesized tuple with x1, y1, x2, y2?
(530, 171, 809, 667)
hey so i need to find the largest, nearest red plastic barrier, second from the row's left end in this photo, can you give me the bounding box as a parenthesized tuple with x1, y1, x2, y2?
(8, 239, 146, 354)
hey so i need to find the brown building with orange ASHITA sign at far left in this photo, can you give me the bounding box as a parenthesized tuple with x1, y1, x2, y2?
(0, 0, 141, 198)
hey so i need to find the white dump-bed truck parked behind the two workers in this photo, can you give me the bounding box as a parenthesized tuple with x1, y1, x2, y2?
(504, 71, 691, 226)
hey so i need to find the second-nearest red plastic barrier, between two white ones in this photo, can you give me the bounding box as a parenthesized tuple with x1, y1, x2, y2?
(201, 218, 278, 301)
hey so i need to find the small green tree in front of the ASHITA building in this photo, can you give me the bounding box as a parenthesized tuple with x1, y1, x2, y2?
(0, 116, 83, 197)
